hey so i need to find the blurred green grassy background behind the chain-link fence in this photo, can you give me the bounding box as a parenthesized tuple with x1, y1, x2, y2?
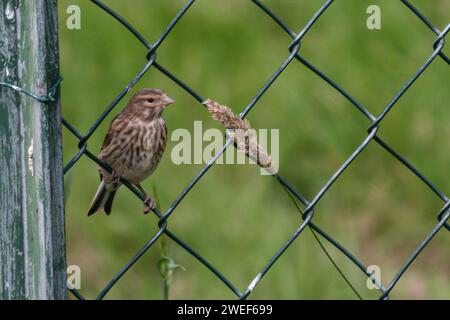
(59, 0, 450, 299)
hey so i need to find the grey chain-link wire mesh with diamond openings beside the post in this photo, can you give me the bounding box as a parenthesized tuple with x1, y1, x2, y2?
(57, 0, 450, 299)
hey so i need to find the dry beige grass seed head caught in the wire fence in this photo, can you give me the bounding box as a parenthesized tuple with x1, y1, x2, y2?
(203, 99, 276, 175)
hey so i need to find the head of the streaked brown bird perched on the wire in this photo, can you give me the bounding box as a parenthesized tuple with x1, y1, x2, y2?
(129, 89, 175, 119)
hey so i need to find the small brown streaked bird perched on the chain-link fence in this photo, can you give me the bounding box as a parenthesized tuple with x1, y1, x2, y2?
(88, 89, 175, 216)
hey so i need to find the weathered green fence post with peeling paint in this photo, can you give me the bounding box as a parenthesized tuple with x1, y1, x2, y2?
(0, 0, 67, 299)
